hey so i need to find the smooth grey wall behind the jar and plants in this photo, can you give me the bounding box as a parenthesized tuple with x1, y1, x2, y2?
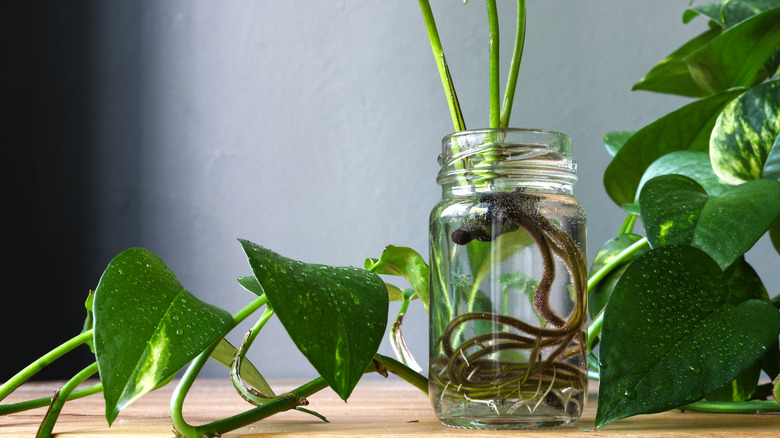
(4, 0, 778, 377)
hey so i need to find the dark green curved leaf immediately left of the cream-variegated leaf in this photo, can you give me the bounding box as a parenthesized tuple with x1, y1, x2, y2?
(604, 91, 740, 206)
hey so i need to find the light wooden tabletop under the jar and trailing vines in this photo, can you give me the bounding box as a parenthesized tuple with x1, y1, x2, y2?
(0, 377, 780, 438)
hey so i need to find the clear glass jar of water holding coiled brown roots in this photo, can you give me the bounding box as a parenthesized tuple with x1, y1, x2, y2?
(429, 129, 587, 429)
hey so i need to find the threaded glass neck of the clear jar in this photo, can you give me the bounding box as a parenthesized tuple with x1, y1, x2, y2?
(436, 129, 577, 194)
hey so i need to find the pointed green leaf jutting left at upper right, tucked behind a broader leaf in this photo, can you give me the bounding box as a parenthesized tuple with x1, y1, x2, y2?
(631, 28, 722, 97)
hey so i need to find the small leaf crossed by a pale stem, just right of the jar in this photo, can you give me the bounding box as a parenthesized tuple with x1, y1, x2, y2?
(588, 234, 649, 318)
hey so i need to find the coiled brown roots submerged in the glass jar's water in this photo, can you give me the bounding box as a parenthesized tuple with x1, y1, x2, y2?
(438, 190, 587, 405)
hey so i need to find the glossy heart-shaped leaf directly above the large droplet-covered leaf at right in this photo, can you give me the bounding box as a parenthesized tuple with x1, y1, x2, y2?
(639, 175, 780, 269)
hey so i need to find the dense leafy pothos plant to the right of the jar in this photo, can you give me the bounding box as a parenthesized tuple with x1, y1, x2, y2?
(589, 0, 780, 427)
